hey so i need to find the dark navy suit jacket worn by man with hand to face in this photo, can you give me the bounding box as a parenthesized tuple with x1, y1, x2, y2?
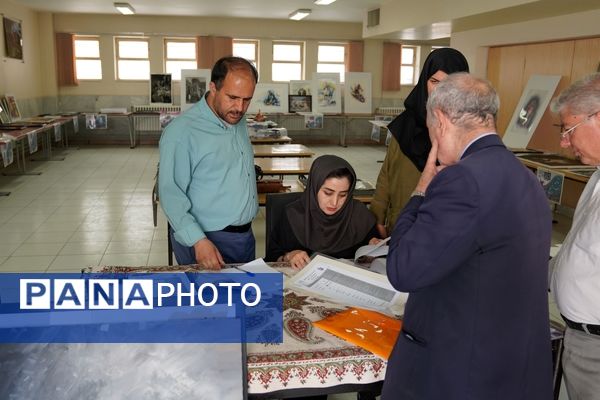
(382, 135, 552, 400)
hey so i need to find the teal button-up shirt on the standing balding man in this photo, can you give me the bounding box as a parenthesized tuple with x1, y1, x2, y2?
(158, 96, 258, 246)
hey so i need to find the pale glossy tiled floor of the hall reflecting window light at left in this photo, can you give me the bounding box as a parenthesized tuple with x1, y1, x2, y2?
(0, 146, 570, 400)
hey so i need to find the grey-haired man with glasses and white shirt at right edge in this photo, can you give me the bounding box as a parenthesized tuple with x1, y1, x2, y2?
(551, 74, 600, 400)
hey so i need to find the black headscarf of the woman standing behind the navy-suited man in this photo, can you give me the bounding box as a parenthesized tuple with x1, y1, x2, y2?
(388, 48, 469, 171)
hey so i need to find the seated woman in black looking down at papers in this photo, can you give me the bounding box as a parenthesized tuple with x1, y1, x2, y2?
(266, 155, 379, 269)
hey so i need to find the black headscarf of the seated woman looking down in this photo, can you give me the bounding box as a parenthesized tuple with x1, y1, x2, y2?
(285, 155, 375, 254)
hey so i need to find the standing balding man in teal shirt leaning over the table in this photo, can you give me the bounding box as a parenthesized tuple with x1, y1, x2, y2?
(158, 57, 258, 269)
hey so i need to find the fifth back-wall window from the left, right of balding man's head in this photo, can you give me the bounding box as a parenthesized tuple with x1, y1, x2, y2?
(271, 42, 304, 82)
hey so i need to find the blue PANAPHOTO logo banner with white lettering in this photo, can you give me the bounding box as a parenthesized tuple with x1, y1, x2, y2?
(0, 273, 283, 343)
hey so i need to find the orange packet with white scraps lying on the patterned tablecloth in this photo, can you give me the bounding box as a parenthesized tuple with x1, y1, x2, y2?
(313, 307, 402, 360)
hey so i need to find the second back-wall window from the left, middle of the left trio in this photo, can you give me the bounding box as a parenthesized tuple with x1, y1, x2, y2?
(115, 38, 150, 80)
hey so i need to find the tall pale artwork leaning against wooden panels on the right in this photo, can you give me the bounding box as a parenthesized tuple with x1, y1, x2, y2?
(502, 75, 560, 149)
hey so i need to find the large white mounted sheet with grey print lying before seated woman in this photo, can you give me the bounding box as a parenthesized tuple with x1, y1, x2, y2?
(286, 255, 408, 314)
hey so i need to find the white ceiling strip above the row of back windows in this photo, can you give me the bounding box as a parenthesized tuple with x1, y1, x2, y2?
(13, 0, 382, 23)
